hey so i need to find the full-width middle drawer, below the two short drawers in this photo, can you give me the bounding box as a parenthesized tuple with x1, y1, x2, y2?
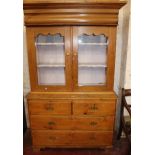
(30, 115, 114, 131)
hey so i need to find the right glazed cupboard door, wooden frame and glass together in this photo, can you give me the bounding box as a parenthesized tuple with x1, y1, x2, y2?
(73, 26, 114, 91)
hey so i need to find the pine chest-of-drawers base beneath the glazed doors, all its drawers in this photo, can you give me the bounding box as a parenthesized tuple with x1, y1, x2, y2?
(28, 93, 116, 150)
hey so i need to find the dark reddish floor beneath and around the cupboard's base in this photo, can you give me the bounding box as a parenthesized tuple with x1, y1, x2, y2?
(23, 130, 129, 155)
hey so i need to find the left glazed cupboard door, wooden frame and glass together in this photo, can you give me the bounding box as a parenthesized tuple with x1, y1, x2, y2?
(28, 27, 71, 91)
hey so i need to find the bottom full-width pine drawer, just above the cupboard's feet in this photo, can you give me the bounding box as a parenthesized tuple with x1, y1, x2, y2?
(32, 130, 113, 146)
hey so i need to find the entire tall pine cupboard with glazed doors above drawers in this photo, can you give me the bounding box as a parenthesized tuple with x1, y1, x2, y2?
(24, 0, 126, 150)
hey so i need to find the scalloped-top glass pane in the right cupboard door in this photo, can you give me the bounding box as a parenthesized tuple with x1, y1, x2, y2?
(78, 34, 108, 86)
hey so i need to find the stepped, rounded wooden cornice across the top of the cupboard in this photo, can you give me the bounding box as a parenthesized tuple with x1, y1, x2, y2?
(23, 0, 126, 26)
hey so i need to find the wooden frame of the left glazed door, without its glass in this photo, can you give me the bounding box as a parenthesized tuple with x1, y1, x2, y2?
(26, 26, 72, 92)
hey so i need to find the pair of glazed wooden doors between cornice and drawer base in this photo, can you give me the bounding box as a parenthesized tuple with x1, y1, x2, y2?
(27, 26, 115, 91)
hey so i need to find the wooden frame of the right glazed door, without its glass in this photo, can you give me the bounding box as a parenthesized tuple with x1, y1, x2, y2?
(73, 26, 116, 91)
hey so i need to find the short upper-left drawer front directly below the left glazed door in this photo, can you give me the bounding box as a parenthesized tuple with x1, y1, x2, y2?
(28, 100, 71, 115)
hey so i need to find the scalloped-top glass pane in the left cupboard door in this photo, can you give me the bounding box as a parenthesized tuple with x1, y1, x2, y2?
(35, 34, 65, 85)
